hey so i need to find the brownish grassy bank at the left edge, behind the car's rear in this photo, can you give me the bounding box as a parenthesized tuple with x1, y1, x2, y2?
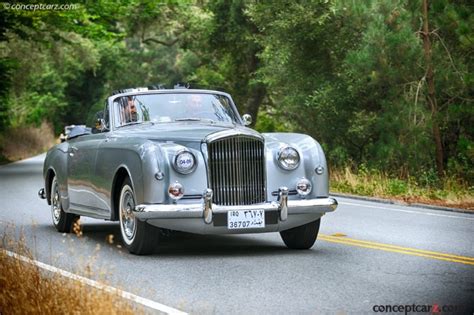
(0, 122, 56, 164)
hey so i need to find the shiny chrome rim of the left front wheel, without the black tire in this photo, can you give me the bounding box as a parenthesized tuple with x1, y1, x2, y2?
(119, 184, 137, 245)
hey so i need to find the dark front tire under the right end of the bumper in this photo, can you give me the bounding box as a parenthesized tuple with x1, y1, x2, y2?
(280, 219, 321, 249)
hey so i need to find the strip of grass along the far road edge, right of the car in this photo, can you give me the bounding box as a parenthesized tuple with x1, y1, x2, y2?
(331, 167, 474, 210)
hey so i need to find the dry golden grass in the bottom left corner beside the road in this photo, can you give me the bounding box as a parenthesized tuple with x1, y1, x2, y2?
(0, 226, 142, 314)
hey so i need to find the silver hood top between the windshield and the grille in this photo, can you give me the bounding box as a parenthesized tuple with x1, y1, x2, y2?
(116, 122, 261, 142)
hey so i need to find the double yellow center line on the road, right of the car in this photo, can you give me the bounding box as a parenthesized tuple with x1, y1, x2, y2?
(318, 234, 474, 266)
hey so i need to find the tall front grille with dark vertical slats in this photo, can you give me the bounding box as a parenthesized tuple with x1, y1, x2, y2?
(208, 136, 265, 206)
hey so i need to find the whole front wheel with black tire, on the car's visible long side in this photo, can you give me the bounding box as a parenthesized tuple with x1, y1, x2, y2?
(119, 178, 159, 255)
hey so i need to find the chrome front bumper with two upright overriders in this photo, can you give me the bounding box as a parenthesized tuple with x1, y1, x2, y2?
(133, 187, 337, 224)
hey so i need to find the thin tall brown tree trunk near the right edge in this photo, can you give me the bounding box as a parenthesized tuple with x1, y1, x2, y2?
(422, 0, 444, 177)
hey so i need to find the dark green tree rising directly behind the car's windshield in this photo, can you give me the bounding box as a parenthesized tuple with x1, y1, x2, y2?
(193, 0, 266, 122)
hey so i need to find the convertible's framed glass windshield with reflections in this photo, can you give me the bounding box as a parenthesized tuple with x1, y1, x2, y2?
(114, 93, 240, 127)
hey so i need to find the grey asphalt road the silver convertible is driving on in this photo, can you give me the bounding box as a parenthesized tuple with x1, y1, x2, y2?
(0, 156, 474, 314)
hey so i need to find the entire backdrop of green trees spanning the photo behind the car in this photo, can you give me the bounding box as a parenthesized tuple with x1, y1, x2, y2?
(0, 0, 474, 190)
